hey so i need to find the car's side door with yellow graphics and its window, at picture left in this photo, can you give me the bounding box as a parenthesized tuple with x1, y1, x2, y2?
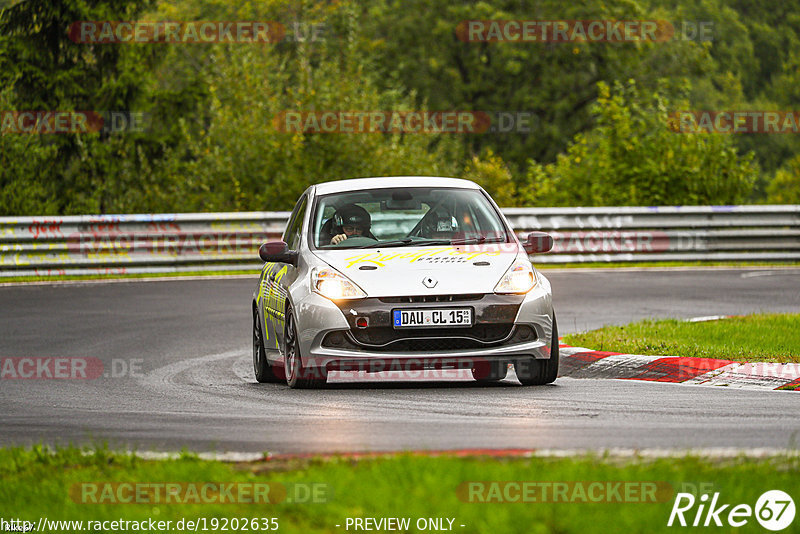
(265, 194, 308, 358)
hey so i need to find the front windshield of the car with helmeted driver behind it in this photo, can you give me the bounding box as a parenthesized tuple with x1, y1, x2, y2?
(311, 187, 509, 249)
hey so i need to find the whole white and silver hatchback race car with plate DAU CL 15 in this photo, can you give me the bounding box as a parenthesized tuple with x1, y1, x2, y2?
(252, 177, 558, 388)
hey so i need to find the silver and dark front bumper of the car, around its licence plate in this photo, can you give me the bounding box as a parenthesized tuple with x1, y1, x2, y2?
(296, 275, 553, 371)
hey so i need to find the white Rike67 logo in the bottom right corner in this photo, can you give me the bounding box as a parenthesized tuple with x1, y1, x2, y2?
(667, 490, 795, 531)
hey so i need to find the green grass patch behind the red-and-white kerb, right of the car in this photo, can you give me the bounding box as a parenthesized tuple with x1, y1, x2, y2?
(563, 314, 800, 363)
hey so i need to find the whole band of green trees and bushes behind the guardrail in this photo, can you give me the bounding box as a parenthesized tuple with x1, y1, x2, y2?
(0, 0, 800, 215)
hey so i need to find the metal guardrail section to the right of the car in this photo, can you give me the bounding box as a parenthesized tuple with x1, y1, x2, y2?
(504, 205, 800, 263)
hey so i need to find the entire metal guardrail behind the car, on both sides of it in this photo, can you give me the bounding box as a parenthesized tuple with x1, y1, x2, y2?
(0, 205, 800, 278)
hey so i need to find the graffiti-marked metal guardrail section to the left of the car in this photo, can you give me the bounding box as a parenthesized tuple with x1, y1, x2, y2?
(0, 212, 289, 278)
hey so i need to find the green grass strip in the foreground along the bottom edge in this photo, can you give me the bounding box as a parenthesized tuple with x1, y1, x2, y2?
(0, 447, 800, 534)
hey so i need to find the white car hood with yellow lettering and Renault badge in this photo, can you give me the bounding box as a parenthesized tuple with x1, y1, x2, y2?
(314, 243, 520, 297)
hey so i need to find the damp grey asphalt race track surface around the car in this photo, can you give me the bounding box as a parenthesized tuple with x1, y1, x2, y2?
(0, 269, 800, 453)
